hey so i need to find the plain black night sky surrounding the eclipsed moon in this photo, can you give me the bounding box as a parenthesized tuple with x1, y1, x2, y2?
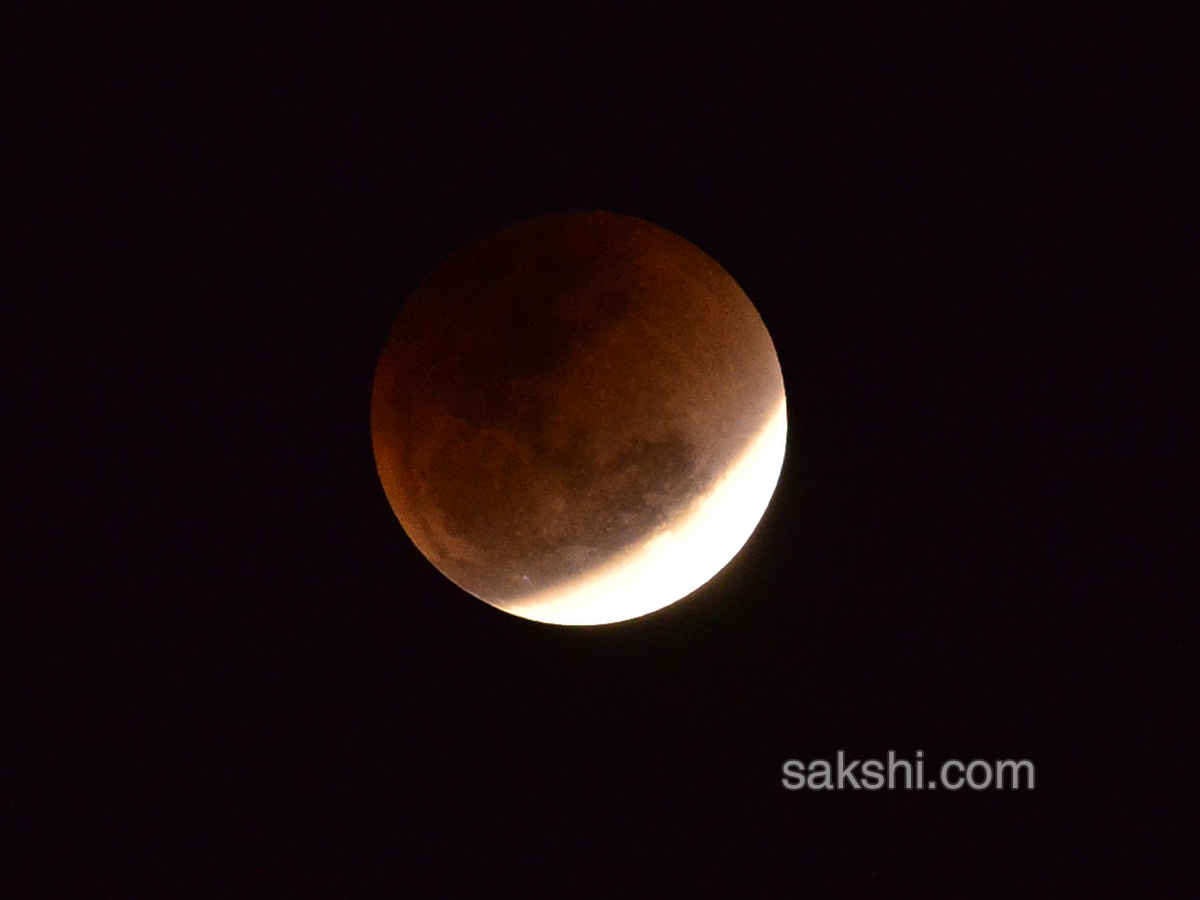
(5, 4, 1200, 896)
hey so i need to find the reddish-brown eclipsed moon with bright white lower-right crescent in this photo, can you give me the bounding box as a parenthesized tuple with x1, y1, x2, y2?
(371, 211, 787, 625)
